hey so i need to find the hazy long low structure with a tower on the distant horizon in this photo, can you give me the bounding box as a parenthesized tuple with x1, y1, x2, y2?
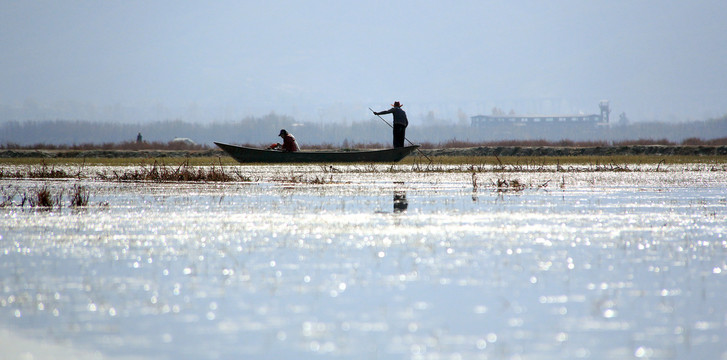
(470, 100, 611, 127)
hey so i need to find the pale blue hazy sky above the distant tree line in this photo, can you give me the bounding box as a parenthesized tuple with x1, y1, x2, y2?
(0, 0, 727, 122)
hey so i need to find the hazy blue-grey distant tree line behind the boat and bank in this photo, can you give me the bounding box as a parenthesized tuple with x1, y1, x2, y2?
(0, 113, 727, 147)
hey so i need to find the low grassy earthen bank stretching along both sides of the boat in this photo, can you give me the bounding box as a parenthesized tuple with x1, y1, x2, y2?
(0, 145, 727, 159)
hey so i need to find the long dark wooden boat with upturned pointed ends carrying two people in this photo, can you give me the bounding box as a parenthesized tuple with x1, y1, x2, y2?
(215, 142, 419, 163)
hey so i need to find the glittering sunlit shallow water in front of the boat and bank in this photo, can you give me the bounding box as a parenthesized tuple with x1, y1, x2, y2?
(0, 165, 727, 359)
